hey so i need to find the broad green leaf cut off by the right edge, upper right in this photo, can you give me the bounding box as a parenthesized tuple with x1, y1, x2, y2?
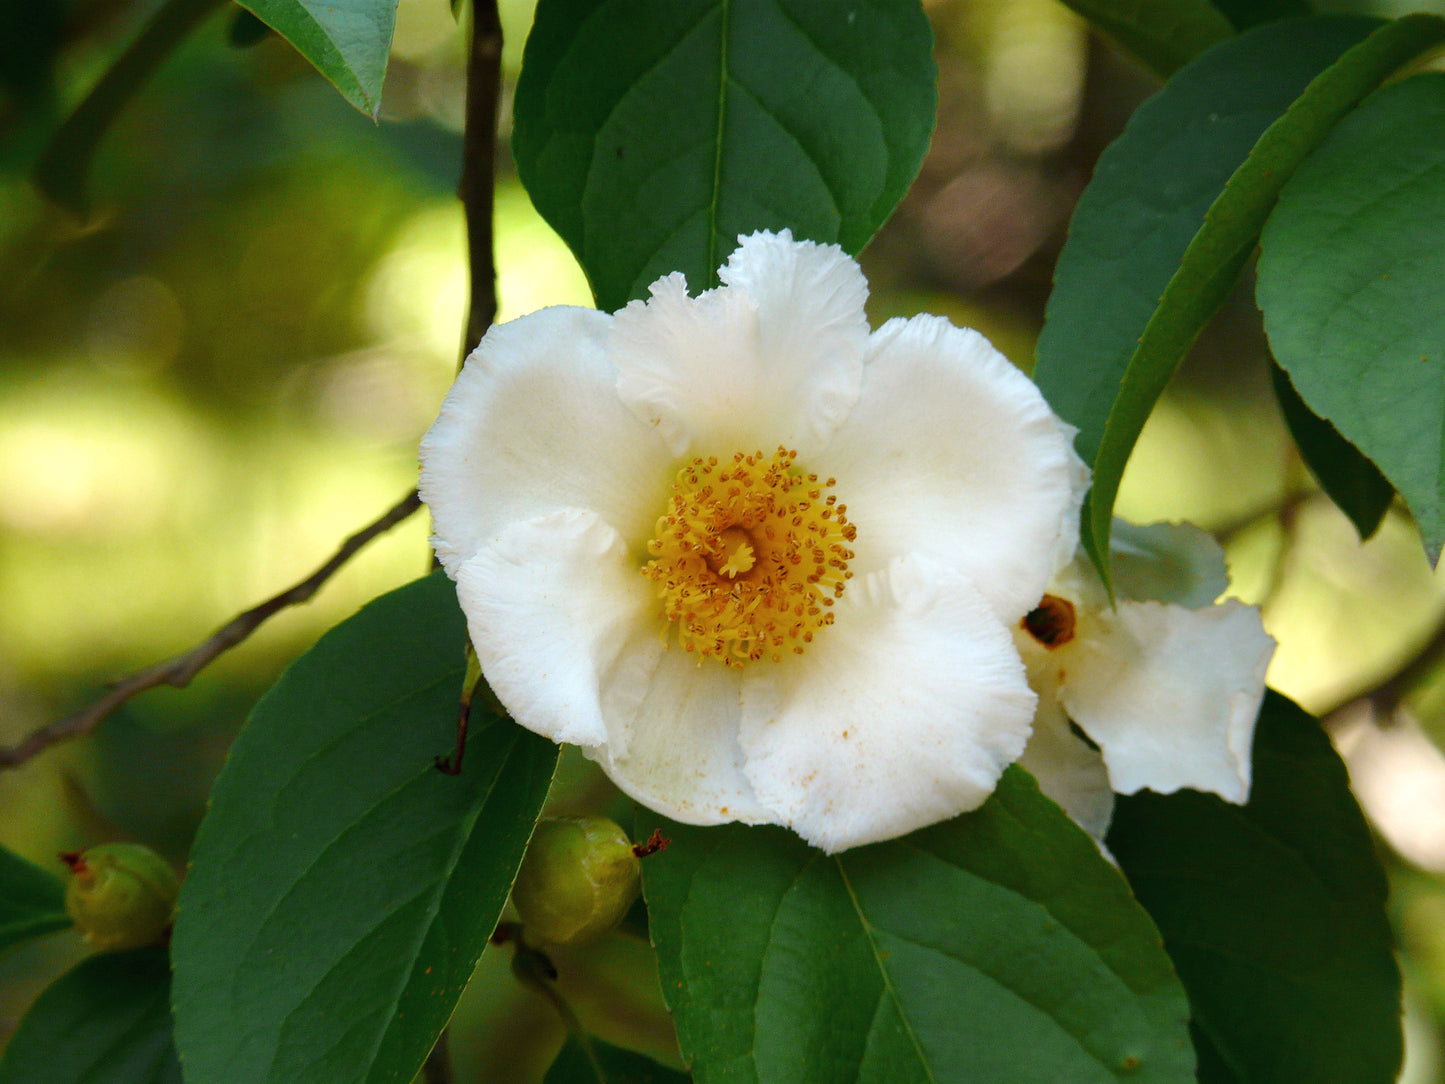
(1257, 72, 1445, 562)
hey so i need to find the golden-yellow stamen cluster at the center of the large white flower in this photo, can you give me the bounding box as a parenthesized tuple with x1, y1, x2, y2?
(642, 448, 858, 668)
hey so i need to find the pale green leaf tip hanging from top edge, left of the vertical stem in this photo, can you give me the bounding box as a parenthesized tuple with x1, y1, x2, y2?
(237, 0, 399, 117)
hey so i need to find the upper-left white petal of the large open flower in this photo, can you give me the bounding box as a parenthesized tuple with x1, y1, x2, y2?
(420, 306, 676, 578)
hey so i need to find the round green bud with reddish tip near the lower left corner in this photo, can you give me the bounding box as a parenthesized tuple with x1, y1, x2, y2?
(61, 843, 181, 952)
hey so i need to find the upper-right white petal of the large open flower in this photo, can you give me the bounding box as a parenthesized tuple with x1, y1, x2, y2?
(826, 317, 1081, 624)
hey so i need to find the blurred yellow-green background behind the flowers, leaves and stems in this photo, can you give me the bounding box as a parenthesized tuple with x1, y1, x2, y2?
(0, 0, 1445, 1084)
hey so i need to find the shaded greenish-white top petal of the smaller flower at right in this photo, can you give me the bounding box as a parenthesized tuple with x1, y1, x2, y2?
(1108, 519, 1230, 610)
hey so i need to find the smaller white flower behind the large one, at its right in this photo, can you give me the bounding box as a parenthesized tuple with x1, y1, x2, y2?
(1014, 520, 1274, 840)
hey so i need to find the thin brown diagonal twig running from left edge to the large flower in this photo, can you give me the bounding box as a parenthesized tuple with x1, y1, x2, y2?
(0, 490, 422, 769)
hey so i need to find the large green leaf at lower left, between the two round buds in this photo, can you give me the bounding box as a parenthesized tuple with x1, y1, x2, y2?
(172, 572, 556, 1084)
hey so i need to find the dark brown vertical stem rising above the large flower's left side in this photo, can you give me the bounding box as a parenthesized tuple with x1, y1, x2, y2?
(457, 0, 501, 358)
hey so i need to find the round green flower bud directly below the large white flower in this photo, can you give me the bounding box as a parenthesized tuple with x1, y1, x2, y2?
(512, 817, 642, 945)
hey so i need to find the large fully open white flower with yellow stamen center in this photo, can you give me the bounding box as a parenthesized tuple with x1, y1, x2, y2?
(420, 231, 1079, 851)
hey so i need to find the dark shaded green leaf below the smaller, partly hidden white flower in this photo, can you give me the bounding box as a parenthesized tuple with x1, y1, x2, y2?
(1108, 692, 1402, 1084)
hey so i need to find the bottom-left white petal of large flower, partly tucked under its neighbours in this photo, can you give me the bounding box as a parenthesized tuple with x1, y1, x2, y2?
(588, 644, 777, 824)
